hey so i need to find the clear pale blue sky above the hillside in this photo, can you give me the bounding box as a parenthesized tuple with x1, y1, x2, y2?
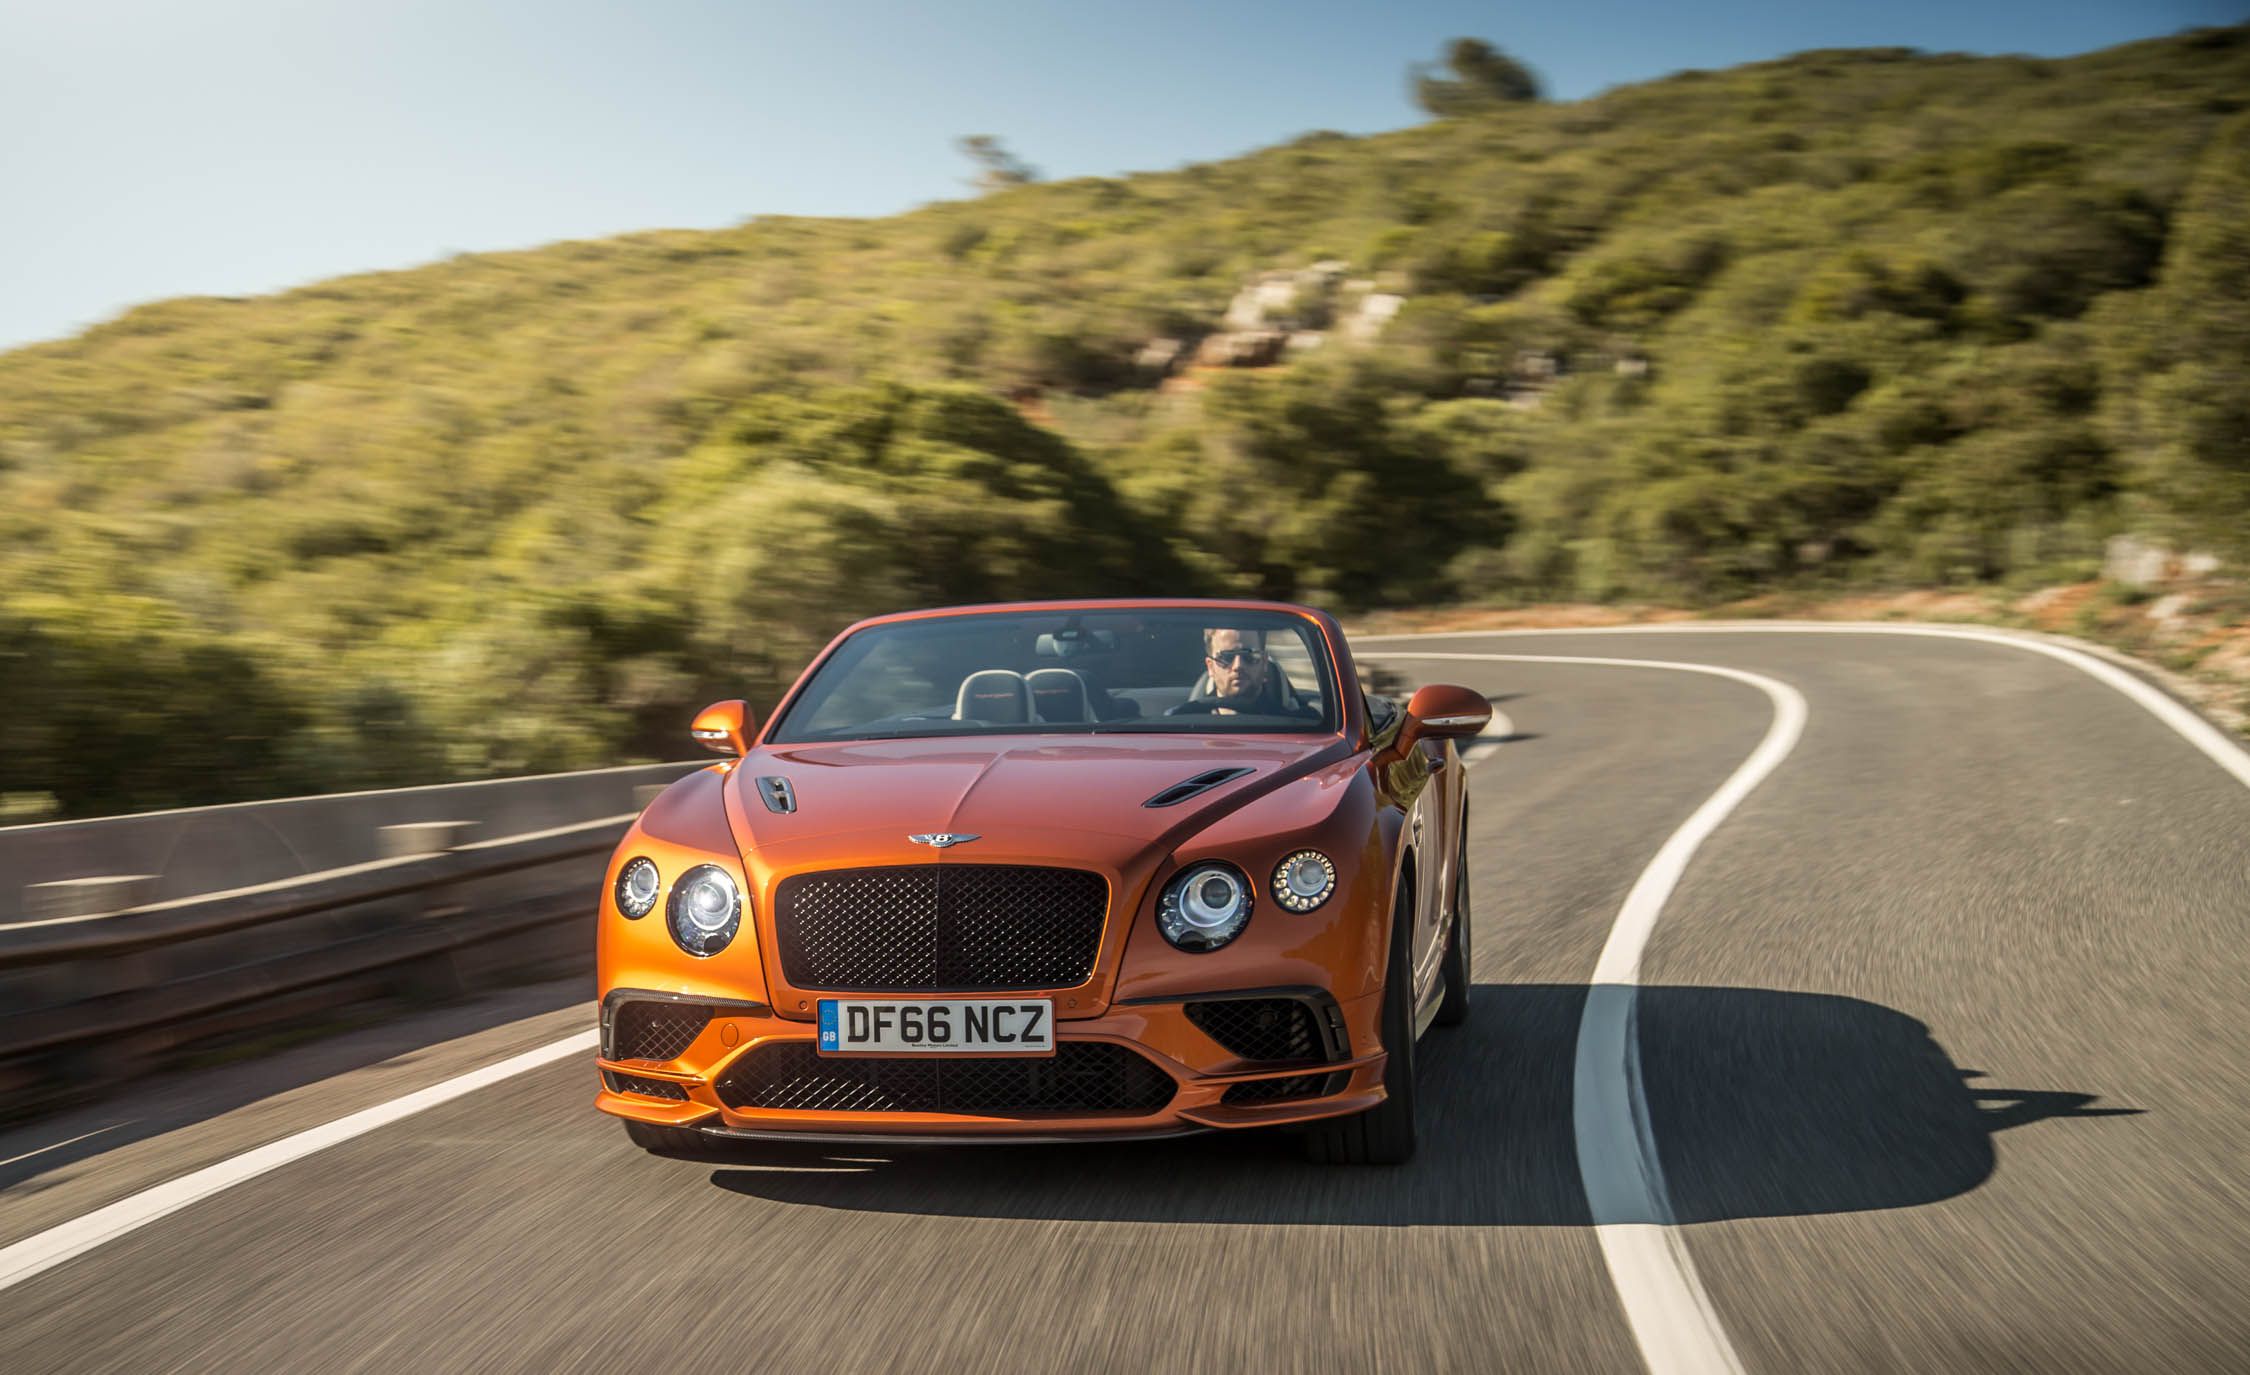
(0, 0, 2250, 349)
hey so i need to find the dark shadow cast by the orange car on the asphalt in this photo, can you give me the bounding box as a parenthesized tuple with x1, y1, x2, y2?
(711, 983, 2135, 1226)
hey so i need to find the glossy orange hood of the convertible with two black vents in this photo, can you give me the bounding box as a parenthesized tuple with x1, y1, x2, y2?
(727, 736, 1346, 871)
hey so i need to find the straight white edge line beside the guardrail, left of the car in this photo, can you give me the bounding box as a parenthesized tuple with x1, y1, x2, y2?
(0, 1028, 601, 1289)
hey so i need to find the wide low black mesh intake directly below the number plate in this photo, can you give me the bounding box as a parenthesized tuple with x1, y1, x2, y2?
(718, 1042, 1175, 1116)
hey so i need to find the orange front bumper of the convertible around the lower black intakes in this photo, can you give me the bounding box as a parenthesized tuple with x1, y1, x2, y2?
(594, 988, 1384, 1143)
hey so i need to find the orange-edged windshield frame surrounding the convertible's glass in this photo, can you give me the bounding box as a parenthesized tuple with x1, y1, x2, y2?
(756, 601, 1352, 747)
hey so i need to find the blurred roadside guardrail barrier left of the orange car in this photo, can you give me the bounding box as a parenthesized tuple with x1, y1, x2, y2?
(0, 763, 702, 1116)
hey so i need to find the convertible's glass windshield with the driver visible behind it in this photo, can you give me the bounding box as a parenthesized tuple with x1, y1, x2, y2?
(767, 608, 1337, 745)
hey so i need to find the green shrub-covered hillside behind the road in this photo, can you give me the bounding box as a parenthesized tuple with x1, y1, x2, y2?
(0, 27, 2250, 815)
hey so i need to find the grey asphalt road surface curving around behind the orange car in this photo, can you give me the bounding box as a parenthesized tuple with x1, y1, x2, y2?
(0, 632, 2250, 1373)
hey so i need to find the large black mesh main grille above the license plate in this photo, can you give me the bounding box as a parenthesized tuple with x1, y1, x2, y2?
(774, 864, 1109, 992)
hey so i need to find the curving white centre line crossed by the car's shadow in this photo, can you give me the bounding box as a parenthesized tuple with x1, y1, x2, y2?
(1379, 650, 1807, 1375)
